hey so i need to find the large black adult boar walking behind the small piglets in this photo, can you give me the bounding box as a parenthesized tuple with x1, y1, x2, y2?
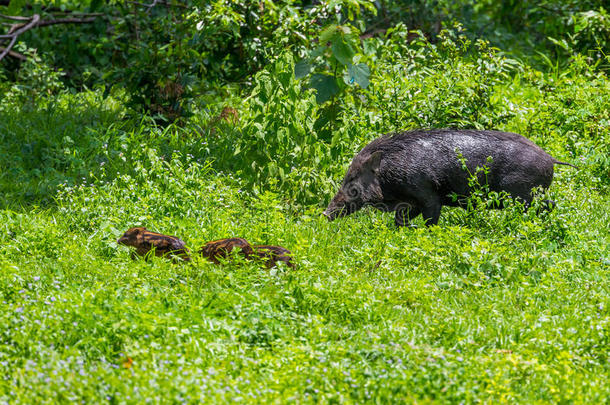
(324, 129, 572, 226)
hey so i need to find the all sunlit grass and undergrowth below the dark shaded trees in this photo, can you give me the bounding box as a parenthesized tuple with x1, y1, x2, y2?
(0, 35, 610, 404)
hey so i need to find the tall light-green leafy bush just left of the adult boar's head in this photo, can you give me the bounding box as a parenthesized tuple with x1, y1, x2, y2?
(219, 54, 334, 203)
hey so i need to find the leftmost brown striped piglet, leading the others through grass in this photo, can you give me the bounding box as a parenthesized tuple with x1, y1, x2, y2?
(117, 227, 191, 261)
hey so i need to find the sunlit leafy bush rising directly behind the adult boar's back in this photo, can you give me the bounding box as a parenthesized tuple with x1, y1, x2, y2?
(360, 26, 519, 130)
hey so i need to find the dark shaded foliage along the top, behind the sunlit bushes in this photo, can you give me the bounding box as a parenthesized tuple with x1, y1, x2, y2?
(0, 0, 610, 120)
